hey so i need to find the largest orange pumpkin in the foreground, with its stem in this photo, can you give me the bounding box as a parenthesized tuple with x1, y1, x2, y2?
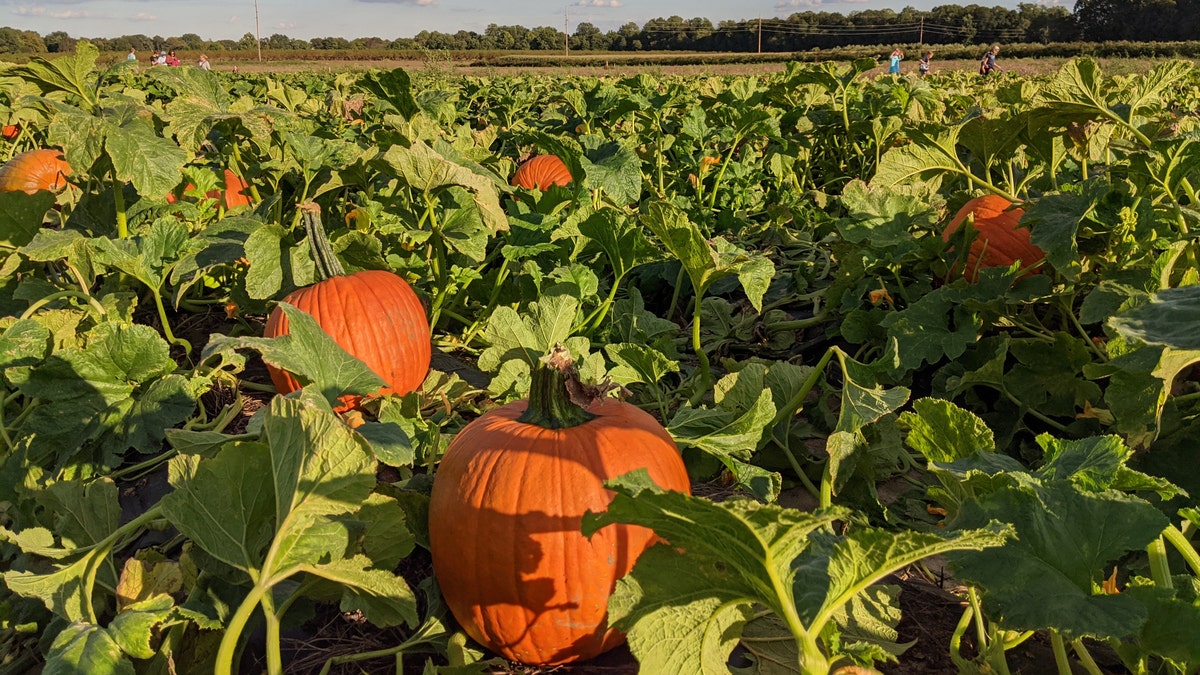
(430, 348, 690, 665)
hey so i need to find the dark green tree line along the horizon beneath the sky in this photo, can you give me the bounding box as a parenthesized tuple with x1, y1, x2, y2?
(0, 0, 1200, 53)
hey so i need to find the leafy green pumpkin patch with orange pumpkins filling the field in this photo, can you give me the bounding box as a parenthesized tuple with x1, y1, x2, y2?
(0, 42, 1200, 675)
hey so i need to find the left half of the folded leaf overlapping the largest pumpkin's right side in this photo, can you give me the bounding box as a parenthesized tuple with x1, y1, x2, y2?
(583, 472, 842, 673)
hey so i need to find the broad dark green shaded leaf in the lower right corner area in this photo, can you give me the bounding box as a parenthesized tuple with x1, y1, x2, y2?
(948, 480, 1168, 638)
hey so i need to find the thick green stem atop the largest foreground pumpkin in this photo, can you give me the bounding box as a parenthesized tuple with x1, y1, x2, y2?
(517, 345, 604, 429)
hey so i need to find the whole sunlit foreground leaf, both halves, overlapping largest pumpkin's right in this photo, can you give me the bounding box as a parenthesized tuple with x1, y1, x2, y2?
(583, 471, 1004, 673)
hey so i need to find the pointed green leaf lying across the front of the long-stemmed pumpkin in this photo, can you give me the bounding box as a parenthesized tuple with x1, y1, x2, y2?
(202, 303, 385, 402)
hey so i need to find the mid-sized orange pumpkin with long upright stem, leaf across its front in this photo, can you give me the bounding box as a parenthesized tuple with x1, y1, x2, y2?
(264, 204, 432, 412)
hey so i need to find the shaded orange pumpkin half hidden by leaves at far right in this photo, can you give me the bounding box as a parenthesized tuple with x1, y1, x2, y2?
(942, 195, 1045, 282)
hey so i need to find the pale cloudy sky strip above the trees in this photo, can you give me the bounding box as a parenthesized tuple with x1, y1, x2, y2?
(0, 0, 1074, 40)
